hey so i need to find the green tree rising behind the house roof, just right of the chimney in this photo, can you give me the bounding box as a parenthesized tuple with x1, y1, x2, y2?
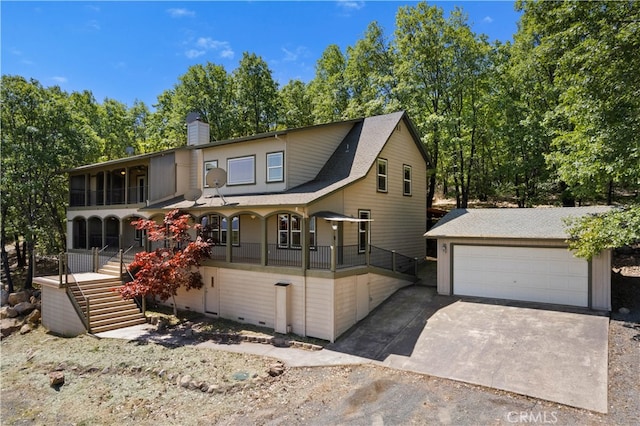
(233, 52, 278, 136)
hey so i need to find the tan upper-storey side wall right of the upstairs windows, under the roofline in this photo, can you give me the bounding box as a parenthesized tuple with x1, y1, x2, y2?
(285, 123, 353, 188)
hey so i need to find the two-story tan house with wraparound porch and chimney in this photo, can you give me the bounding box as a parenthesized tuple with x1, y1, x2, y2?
(67, 112, 428, 341)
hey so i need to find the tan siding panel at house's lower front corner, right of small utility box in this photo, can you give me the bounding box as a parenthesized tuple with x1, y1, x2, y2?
(306, 277, 335, 341)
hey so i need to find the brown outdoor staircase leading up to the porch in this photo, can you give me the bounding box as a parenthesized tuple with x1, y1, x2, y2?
(73, 262, 146, 334)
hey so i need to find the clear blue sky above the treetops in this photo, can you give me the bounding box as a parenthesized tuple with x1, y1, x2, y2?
(0, 0, 519, 108)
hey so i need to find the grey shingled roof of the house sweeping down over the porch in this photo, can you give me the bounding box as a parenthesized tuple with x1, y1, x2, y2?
(148, 111, 428, 209)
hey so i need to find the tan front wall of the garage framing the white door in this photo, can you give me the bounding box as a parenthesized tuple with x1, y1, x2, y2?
(437, 238, 611, 310)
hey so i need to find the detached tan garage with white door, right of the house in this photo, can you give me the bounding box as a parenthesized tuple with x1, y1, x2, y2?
(425, 206, 611, 311)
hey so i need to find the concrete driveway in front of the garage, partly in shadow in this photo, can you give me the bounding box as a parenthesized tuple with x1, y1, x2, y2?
(327, 286, 609, 413)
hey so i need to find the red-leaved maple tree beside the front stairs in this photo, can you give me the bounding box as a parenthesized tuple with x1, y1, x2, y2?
(118, 210, 210, 315)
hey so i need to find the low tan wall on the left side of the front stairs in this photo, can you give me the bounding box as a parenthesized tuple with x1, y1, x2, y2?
(40, 282, 87, 337)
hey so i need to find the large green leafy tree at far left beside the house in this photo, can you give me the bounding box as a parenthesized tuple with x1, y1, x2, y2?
(0, 76, 99, 287)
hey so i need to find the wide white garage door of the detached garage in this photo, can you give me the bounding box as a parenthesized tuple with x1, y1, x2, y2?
(453, 245, 589, 307)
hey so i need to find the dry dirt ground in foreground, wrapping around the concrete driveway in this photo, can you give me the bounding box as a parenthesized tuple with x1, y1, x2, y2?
(0, 256, 640, 425)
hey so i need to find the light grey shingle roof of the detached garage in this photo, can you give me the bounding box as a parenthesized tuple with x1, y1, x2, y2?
(424, 206, 612, 240)
